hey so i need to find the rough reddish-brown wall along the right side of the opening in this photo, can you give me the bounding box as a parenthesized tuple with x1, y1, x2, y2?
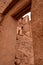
(32, 0, 43, 65)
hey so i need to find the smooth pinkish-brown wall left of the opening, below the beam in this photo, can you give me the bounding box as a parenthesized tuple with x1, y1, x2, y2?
(0, 15, 16, 65)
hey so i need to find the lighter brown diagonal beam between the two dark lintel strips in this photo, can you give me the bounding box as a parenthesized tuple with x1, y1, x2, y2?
(9, 0, 31, 15)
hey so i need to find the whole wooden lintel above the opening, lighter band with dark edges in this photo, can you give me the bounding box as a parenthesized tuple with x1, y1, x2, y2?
(3, 0, 32, 19)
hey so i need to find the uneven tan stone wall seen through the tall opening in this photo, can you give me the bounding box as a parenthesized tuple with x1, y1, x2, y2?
(15, 17, 34, 65)
